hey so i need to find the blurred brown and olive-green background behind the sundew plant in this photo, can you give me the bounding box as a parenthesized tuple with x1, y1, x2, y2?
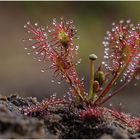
(0, 1, 140, 115)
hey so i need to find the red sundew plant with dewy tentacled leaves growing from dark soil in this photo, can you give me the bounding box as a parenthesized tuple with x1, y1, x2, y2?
(21, 18, 140, 130)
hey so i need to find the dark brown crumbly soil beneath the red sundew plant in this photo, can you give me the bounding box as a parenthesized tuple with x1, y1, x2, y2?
(0, 95, 140, 139)
